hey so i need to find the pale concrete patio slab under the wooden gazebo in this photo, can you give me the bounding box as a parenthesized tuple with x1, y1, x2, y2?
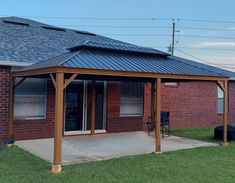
(15, 131, 218, 164)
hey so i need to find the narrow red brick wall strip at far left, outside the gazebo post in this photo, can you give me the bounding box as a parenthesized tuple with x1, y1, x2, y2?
(0, 66, 11, 141)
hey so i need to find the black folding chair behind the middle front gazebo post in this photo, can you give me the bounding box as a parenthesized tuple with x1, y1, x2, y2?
(145, 111, 171, 138)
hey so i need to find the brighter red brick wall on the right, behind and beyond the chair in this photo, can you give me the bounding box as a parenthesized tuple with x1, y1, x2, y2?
(144, 82, 235, 128)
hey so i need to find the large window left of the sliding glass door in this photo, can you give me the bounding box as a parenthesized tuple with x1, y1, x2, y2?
(14, 78, 46, 119)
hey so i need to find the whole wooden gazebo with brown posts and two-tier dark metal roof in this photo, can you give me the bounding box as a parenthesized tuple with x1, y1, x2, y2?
(9, 42, 229, 173)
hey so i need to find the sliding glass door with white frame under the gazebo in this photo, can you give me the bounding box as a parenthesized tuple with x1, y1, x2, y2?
(65, 80, 107, 135)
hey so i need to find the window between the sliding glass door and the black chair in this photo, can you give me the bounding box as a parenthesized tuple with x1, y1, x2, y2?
(120, 82, 144, 116)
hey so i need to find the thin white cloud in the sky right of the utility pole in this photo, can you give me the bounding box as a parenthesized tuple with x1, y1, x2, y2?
(192, 41, 235, 48)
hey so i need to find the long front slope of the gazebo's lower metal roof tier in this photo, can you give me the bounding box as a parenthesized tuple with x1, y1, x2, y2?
(58, 50, 226, 76)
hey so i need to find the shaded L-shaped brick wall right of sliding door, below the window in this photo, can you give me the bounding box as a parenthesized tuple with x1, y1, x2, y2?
(106, 82, 143, 133)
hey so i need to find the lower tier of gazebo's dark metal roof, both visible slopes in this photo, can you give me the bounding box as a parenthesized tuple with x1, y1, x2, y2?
(18, 46, 229, 77)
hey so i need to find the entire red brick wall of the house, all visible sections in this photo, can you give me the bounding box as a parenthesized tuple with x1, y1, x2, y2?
(0, 78, 235, 140)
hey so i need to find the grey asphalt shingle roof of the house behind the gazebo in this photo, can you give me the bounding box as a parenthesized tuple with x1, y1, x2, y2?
(0, 17, 140, 63)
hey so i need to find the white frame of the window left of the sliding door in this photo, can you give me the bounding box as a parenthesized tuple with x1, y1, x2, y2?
(13, 78, 48, 120)
